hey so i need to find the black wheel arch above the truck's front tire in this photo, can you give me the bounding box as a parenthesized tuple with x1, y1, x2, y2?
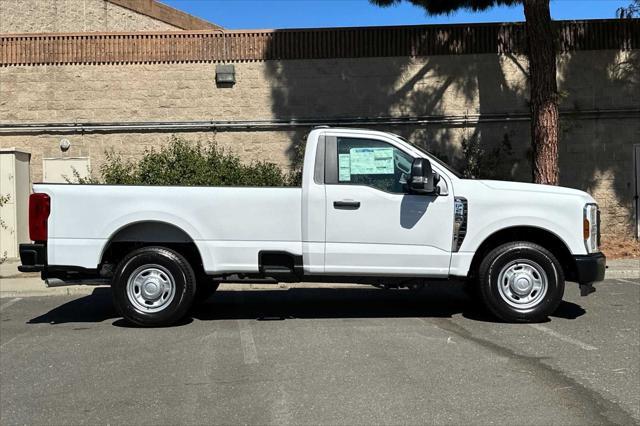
(468, 225, 577, 281)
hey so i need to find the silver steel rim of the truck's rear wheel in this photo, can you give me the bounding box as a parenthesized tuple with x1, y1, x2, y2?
(127, 265, 176, 312)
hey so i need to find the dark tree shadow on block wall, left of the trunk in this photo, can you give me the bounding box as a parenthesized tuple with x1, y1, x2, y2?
(266, 29, 531, 181)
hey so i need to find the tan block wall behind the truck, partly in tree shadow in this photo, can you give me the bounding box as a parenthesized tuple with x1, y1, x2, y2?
(0, 50, 640, 235)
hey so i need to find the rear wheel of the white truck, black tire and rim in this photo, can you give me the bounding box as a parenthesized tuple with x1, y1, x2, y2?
(111, 247, 196, 327)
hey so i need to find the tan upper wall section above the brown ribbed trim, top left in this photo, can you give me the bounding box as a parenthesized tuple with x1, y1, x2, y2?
(0, 0, 179, 33)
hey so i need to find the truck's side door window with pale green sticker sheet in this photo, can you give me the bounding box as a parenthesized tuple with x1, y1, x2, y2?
(337, 137, 413, 193)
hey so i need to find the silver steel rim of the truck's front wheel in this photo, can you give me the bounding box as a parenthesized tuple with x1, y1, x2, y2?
(498, 259, 548, 310)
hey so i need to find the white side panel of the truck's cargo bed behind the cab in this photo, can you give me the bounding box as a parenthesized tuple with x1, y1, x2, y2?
(34, 184, 302, 273)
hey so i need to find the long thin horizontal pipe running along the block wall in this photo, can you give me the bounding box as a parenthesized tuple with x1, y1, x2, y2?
(0, 108, 640, 135)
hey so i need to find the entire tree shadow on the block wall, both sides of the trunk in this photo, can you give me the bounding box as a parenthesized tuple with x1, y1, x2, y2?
(266, 25, 640, 235)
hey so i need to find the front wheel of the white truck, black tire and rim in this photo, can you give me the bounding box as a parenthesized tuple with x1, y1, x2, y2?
(478, 241, 564, 322)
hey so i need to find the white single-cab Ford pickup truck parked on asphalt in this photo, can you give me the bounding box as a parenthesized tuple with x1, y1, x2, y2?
(20, 128, 605, 326)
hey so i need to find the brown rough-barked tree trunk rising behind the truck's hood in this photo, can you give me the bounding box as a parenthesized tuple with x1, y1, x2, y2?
(524, 0, 558, 185)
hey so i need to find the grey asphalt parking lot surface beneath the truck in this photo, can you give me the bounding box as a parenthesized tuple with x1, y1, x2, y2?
(0, 279, 640, 425)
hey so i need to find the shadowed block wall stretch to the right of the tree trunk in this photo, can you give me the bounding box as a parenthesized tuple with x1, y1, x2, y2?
(558, 33, 640, 233)
